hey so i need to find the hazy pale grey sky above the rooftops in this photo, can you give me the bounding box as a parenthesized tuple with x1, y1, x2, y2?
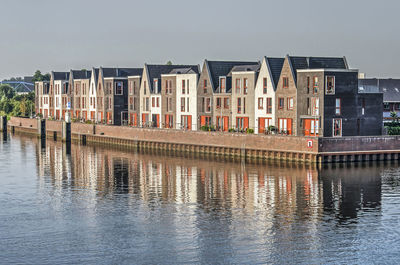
(0, 0, 400, 79)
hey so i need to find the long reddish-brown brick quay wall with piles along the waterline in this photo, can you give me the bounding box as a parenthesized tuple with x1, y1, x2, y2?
(8, 117, 400, 163)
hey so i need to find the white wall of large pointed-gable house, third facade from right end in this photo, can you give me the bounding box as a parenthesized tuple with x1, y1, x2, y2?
(252, 59, 276, 134)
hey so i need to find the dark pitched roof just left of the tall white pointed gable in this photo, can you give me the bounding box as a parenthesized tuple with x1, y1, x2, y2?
(204, 60, 259, 92)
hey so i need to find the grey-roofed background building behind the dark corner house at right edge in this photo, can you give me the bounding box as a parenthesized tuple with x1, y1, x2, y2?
(358, 78, 400, 120)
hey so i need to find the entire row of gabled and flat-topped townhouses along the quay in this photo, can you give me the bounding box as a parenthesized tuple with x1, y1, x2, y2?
(35, 55, 383, 137)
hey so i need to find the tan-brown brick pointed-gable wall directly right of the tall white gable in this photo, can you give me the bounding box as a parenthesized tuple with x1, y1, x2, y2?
(275, 57, 297, 135)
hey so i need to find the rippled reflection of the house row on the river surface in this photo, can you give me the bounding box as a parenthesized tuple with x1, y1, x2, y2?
(32, 135, 382, 226)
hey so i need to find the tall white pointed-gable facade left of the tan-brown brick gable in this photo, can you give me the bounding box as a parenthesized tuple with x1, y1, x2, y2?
(253, 57, 275, 134)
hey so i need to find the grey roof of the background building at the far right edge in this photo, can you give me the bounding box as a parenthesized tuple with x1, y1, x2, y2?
(358, 78, 400, 102)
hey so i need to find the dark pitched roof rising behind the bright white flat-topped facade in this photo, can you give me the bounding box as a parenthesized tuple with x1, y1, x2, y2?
(144, 64, 198, 93)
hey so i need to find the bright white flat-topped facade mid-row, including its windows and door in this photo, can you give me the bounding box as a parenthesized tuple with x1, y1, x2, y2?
(176, 73, 198, 130)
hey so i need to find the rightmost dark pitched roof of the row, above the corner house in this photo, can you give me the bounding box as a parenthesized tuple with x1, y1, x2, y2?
(287, 55, 349, 83)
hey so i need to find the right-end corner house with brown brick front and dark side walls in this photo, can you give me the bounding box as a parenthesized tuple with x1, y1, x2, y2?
(297, 68, 382, 137)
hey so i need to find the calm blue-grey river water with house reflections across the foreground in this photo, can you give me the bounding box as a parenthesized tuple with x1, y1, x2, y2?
(0, 135, 400, 264)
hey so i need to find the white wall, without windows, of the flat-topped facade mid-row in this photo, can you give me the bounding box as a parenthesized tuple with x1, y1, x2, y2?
(175, 74, 198, 130)
